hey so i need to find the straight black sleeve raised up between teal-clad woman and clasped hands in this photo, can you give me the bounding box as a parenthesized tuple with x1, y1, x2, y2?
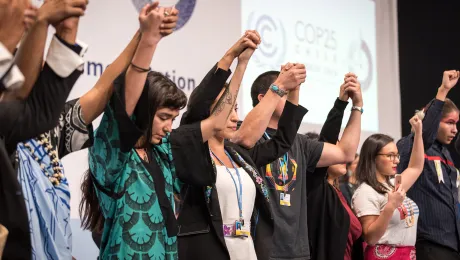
(180, 64, 232, 125)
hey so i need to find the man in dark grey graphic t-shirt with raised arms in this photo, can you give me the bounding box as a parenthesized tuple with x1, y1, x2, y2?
(232, 68, 363, 260)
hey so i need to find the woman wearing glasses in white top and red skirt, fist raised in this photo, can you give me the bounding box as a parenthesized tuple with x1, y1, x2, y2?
(352, 116, 424, 260)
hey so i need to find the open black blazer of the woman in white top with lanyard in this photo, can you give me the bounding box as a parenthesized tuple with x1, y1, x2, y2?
(173, 62, 306, 259)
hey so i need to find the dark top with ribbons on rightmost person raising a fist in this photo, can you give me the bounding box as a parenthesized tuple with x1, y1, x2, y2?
(397, 99, 460, 252)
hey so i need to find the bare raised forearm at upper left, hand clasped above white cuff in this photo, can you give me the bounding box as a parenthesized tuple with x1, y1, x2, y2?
(5, 0, 87, 100)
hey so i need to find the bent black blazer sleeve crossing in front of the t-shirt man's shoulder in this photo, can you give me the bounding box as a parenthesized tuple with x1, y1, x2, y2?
(249, 101, 308, 167)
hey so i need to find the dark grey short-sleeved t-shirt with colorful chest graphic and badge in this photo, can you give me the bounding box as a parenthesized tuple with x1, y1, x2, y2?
(261, 129, 324, 260)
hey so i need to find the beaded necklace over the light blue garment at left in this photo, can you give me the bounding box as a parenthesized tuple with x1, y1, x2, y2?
(24, 133, 65, 186)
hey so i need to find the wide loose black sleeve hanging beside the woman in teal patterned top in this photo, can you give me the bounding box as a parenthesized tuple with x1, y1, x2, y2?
(169, 122, 216, 186)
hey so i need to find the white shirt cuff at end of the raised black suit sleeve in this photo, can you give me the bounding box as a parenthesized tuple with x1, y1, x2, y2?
(46, 36, 88, 78)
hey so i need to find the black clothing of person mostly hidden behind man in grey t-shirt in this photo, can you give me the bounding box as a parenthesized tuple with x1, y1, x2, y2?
(307, 99, 363, 260)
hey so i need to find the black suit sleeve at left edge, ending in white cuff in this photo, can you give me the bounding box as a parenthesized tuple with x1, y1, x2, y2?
(0, 63, 81, 151)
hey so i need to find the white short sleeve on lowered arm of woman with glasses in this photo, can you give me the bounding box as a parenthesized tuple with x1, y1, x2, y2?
(351, 184, 385, 218)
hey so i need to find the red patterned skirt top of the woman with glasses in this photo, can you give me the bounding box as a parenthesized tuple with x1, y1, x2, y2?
(364, 245, 416, 260)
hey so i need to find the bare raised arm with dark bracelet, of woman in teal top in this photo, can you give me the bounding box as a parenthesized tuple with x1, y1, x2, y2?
(125, 1, 164, 116)
